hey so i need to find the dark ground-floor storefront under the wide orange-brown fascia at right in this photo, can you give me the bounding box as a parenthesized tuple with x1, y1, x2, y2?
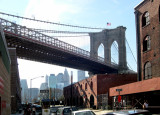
(110, 78, 160, 112)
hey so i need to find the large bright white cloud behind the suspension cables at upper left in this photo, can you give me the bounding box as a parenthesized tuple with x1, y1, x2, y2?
(21, 0, 93, 49)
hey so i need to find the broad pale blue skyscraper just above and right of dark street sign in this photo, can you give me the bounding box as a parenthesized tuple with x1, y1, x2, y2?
(48, 74, 57, 88)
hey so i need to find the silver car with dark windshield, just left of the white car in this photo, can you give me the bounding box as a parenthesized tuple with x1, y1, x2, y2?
(57, 107, 78, 115)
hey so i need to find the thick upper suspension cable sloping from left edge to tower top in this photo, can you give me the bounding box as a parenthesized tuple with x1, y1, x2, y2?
(0, 12, 105, 30)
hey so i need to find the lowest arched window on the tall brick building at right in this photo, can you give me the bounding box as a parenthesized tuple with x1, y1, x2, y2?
(144, 62, 152, 79)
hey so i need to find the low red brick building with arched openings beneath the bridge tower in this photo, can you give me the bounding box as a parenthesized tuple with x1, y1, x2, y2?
(64, 74, 137, 108)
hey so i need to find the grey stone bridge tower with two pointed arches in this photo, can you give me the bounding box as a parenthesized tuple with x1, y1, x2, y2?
(89, 26, 128, 73)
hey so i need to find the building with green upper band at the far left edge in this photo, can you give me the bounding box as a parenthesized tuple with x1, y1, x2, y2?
(0, 24, 11, 115)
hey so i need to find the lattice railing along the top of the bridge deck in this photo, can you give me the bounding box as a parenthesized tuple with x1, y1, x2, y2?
(0, 18, 118, 68)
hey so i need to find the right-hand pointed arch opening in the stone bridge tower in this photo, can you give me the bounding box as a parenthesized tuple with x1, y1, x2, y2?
(111, 41, 119, 64)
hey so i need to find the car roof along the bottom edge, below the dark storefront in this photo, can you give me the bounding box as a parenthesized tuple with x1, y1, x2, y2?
(103, 109, 152, 115)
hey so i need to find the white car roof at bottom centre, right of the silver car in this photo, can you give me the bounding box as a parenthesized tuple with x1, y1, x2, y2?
(72, 110, 96, 115)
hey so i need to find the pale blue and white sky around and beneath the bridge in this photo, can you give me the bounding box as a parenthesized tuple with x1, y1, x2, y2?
(0, 0, 142, 88)
